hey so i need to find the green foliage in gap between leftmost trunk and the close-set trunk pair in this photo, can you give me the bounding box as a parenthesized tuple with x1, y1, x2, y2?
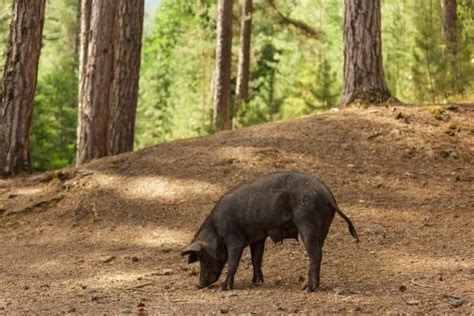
(30, 0, 80, 170)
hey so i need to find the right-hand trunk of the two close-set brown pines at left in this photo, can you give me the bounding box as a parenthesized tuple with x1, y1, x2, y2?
(109, 0, 144, 155)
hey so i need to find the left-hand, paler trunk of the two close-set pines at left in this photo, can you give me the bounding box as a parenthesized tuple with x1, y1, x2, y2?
(76, 0, 118, 164)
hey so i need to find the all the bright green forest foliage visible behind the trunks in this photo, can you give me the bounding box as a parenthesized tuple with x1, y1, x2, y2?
(0, 0, 474, 169)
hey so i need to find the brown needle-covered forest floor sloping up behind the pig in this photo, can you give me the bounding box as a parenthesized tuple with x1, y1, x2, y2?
(0, 104, 474, 314)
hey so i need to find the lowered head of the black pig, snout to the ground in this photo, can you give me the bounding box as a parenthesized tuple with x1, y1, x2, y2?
(181, 241, 227, 288)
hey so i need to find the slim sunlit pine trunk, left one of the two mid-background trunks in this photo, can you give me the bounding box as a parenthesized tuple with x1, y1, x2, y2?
(212, 0, 233, 131)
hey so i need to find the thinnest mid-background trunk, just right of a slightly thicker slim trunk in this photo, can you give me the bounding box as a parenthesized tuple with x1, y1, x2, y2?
(236, 0, 252, 102)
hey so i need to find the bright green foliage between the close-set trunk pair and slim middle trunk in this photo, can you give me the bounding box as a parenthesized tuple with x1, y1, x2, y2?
(136, 0, 215, 147)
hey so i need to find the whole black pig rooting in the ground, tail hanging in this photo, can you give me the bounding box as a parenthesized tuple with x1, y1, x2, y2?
(181, 171, 359, 291)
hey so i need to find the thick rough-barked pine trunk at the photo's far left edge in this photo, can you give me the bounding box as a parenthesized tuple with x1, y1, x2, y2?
(0, 0, 46, 174)
